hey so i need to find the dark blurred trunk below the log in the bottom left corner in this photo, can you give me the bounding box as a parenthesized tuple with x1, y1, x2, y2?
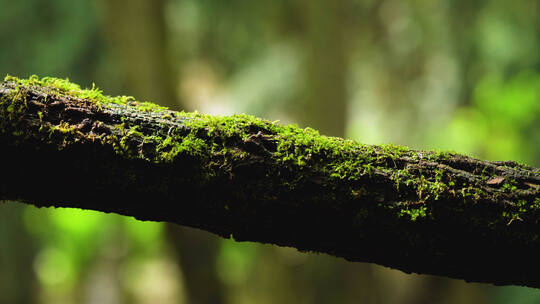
(0, 204, 37, 304)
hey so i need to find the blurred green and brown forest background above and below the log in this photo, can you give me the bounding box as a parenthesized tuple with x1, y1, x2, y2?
(0, 0, 540, 304)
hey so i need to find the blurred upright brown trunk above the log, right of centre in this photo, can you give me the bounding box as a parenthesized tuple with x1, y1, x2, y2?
(299, 1, 347, 136)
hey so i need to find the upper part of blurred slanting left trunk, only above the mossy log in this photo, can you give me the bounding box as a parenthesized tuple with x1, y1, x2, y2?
(100, 0, 180, 110)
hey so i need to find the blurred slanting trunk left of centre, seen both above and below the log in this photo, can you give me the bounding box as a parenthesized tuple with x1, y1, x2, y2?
(97, 0, 224, 304)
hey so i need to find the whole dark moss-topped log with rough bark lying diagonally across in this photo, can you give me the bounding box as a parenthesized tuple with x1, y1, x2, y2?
(0, 77, 540, 287)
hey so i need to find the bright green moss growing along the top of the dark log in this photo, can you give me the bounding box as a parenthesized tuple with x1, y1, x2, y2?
(5, 76, 540, 226)
